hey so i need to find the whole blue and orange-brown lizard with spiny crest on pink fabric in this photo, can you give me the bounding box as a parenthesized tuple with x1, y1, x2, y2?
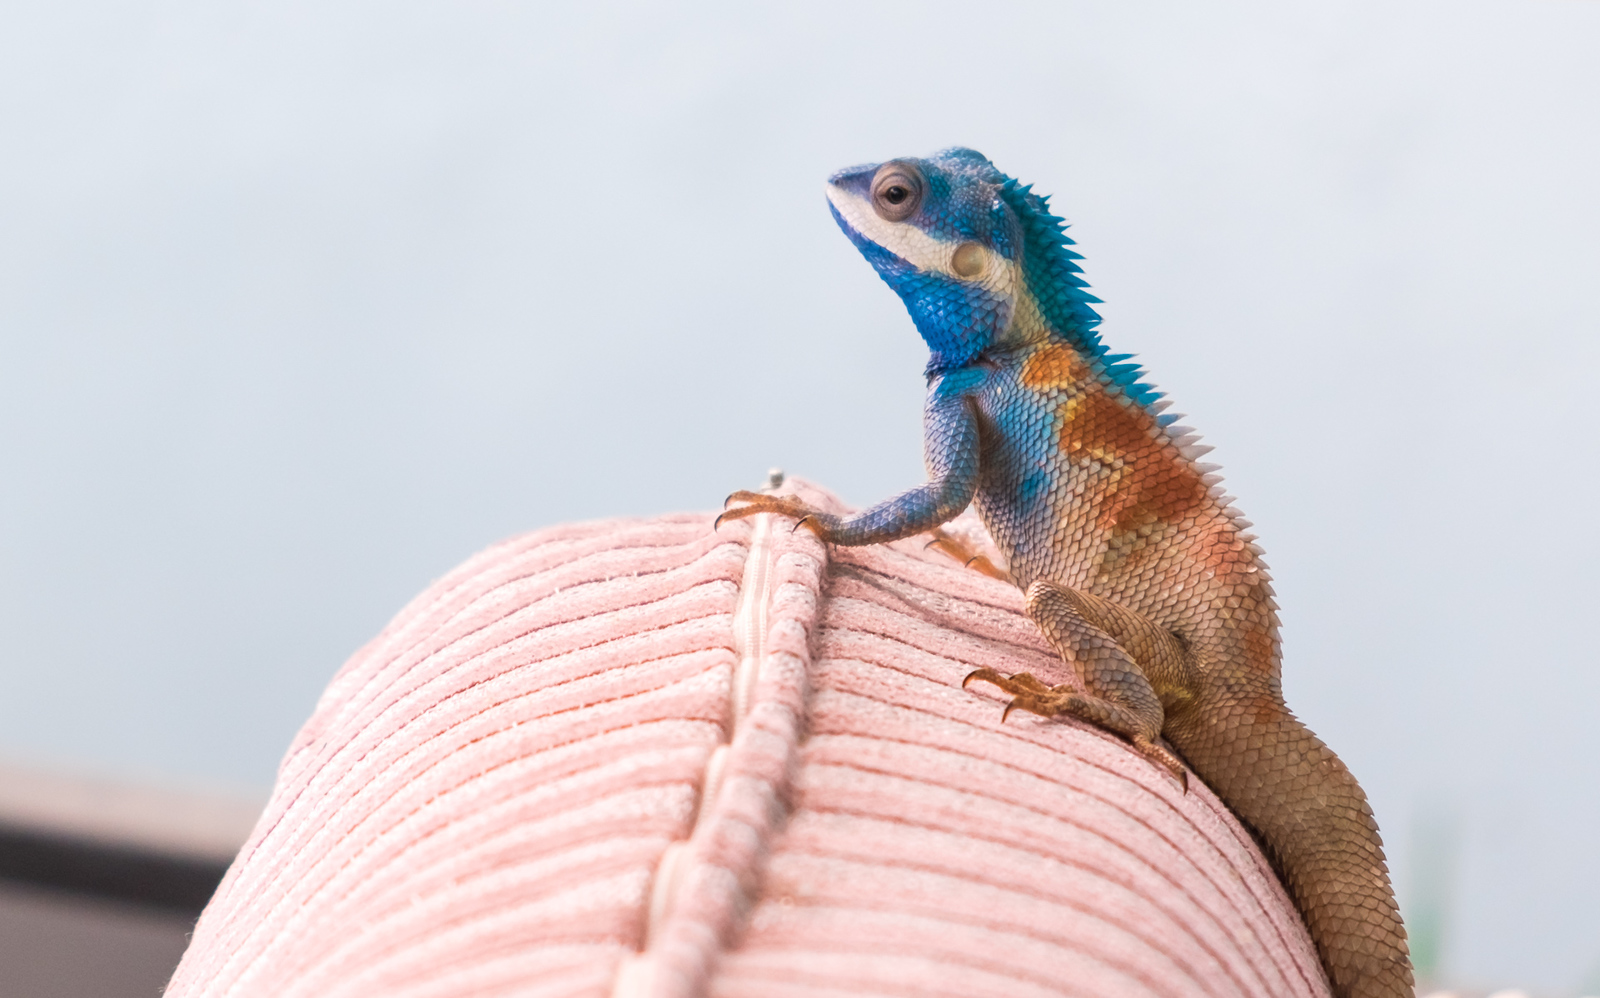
(718, 147, 1413, 998)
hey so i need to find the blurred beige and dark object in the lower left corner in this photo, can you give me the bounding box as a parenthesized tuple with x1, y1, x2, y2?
(0, 764, 261, 998)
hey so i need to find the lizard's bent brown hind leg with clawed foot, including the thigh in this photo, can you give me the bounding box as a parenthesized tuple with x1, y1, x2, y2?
(962, 582, 1189, 788)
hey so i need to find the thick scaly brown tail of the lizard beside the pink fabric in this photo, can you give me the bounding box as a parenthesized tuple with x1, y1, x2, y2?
(1166, 696, 1413, 998)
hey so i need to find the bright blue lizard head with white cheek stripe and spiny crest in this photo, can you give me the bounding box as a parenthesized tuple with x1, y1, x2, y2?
(827, 149, 1099, 371)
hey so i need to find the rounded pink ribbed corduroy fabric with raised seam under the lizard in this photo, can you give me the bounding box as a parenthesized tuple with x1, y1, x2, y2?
(166, 486, 1328, 998)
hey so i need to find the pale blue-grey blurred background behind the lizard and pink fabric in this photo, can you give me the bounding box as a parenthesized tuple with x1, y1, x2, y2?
(0, 0, 1600, 995)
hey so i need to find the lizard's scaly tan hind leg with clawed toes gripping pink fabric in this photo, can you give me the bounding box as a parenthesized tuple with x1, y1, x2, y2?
(962, 582, 1189, 788)
